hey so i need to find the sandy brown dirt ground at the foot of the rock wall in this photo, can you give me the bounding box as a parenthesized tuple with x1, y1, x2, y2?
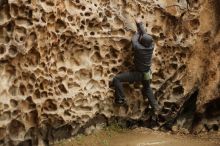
(53, 128, 220, 146)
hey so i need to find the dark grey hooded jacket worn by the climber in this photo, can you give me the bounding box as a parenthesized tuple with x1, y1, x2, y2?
(132, 23, 154, 72)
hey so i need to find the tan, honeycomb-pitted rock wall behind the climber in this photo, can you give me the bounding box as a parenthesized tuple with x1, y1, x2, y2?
(0, 0, 220, 145)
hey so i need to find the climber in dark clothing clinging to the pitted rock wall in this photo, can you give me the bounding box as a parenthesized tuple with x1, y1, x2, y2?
(113, 19, 160, 112)
